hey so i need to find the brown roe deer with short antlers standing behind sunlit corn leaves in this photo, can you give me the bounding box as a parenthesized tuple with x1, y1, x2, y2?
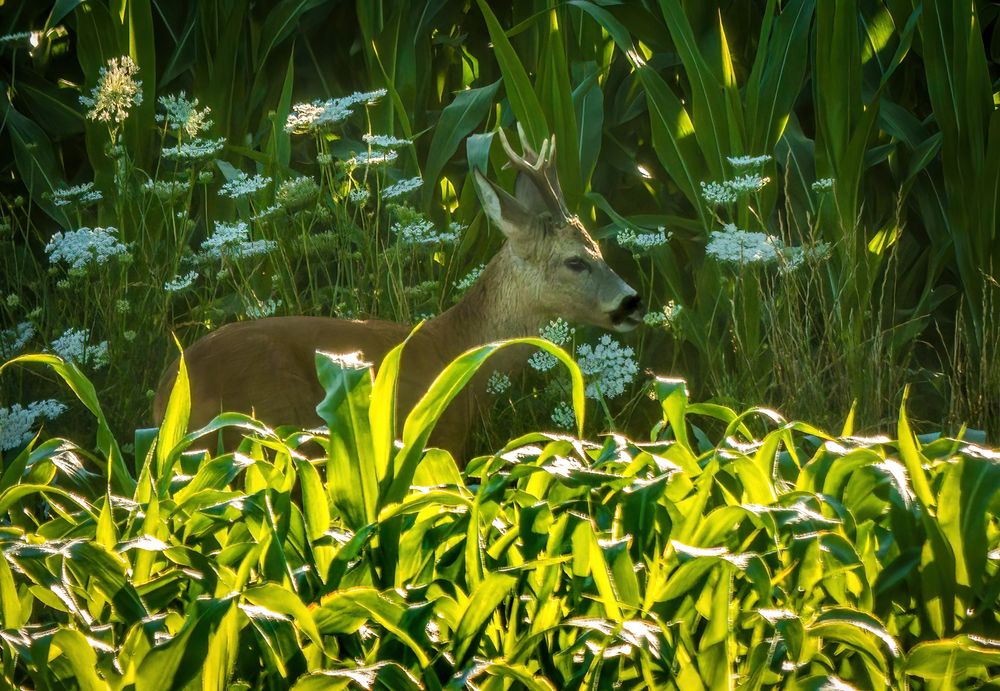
(154, 126, 642, 465)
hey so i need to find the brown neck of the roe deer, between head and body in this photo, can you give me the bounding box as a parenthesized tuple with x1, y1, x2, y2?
(424, 244, 546, 360)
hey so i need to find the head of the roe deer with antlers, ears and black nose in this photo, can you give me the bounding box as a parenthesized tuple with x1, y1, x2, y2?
(474, 125, 643, 331)
